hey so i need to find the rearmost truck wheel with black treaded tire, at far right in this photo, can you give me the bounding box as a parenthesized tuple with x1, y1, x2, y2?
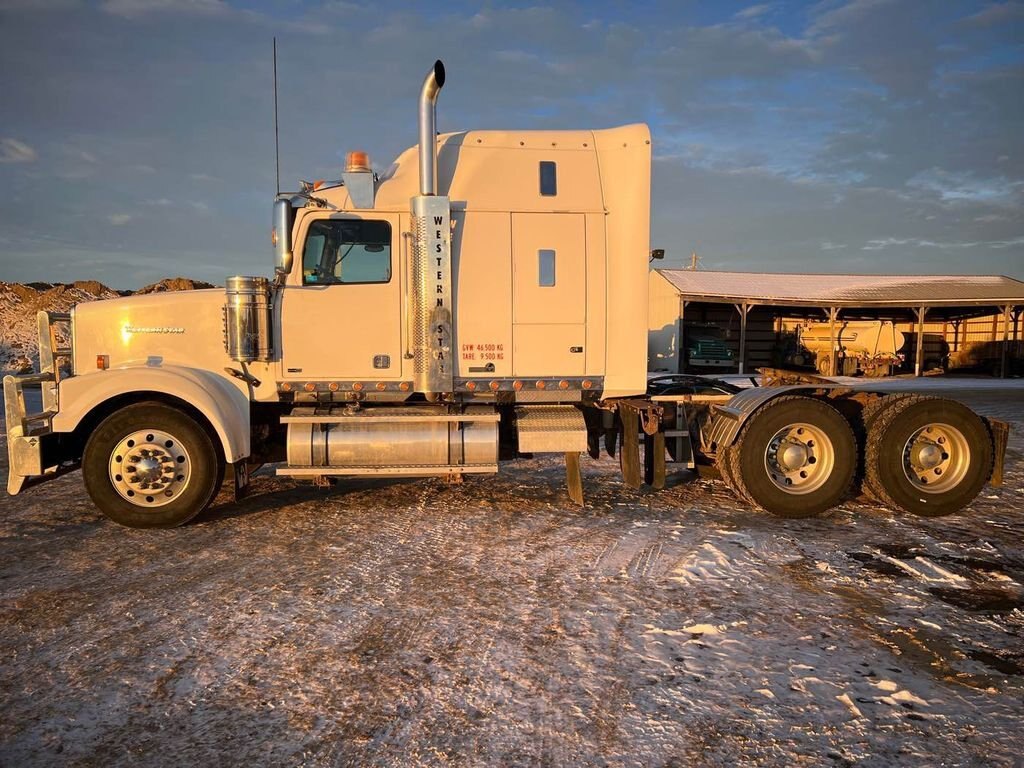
(864, 395, 994, 517)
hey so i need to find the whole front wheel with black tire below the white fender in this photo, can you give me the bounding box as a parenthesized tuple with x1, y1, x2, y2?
(82, 402, 224, 528)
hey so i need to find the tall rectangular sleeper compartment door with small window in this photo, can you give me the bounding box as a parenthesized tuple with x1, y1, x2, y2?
(512, 213, 587, 377)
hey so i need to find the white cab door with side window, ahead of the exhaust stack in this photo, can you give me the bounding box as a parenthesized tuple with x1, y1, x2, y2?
(281, 212, 402, 380)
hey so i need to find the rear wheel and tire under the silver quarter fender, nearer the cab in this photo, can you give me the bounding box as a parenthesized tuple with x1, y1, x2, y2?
(726, 395, 857, 518)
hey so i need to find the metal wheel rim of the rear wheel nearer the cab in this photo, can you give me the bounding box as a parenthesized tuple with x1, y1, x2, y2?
(765, 423, 836, 496)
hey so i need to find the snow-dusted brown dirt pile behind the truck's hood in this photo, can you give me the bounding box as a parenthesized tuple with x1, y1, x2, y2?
(0, 278, 213, 374)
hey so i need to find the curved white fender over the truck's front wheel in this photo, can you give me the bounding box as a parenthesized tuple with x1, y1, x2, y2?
(52, 366, 251, 463)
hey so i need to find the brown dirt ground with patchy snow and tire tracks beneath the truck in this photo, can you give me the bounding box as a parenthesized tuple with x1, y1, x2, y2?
(0, 382, 1024, 766)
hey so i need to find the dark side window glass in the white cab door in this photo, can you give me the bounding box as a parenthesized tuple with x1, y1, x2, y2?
(302, 219, 391, 286)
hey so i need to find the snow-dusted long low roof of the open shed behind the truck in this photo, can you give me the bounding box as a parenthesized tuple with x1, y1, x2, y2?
(656, 269, 1024, 307)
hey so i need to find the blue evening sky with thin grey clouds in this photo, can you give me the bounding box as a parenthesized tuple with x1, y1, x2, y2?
(0, 0, 1024, 289)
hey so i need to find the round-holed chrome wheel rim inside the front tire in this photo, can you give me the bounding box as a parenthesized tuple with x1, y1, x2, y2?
(108, 429, 191, 507)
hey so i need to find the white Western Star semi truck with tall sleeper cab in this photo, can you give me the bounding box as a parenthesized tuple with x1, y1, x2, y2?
(4, 61, 1006, 527)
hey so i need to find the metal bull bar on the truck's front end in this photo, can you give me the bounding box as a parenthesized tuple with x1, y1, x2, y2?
(3, 311, 72, 496)
